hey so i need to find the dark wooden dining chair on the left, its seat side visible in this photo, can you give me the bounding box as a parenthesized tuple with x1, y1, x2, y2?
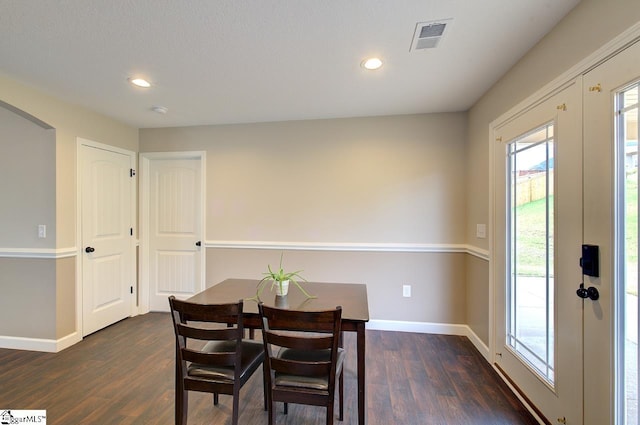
(169, 296, 267, 425)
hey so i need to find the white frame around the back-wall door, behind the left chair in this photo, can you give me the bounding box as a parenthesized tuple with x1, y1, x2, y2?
(138, 151, 207, 314)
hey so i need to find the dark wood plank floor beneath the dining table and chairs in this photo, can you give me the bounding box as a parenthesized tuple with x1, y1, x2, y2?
(0, 313, 536, 425)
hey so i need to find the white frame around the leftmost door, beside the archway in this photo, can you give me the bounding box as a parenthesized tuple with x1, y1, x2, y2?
(76, 137, 139, 339)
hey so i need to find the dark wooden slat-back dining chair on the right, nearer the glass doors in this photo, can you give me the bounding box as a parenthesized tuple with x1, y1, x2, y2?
(258, 303, 345, 425)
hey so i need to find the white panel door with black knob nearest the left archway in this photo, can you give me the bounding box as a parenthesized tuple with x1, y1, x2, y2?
(80, 144, 135, 336)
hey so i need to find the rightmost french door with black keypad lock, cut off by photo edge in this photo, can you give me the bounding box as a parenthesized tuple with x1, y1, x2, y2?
(583, 39, 640, 425)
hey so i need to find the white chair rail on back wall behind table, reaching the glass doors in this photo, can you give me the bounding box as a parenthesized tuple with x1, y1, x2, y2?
(204, 241, 489, 260)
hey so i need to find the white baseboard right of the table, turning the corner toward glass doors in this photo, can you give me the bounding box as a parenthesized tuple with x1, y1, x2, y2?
(367, 320, 489, 362)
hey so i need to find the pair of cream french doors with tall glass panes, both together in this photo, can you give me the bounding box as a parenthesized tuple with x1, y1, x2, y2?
(492, 39, 640, 425)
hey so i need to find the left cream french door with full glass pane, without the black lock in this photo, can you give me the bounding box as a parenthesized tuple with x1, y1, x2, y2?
(492, 84, 583, 424)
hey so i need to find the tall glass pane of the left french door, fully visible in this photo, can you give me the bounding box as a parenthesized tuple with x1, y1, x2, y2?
(506, 123, 555, 385)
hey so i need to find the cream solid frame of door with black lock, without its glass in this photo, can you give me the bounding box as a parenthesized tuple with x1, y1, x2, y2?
(583, 39, 640, 425)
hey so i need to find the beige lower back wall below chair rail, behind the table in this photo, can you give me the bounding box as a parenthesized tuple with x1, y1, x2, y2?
(207, 249, 465, 324)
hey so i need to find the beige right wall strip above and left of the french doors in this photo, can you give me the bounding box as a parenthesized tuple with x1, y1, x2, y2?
(466, 0, 640, 343)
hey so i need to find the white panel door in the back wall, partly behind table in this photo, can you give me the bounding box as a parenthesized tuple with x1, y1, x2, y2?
(144, 153, 204, 311)
